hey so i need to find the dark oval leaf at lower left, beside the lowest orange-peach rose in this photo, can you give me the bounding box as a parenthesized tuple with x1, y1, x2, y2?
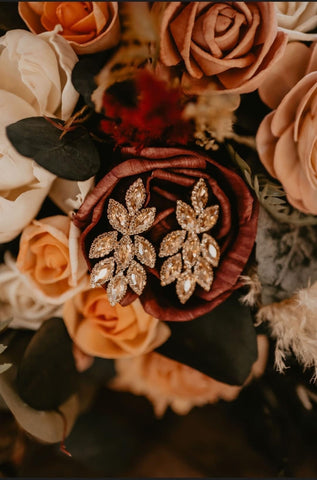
(17, 318, 79, 410)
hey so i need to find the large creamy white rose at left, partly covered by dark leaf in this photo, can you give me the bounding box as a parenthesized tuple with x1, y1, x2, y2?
(0, 30, 79, 242)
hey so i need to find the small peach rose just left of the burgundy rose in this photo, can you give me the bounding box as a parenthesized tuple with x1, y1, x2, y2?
(17, 215, 87, 305)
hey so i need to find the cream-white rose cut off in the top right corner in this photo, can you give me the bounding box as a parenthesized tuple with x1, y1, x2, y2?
(275, 2, 317, 42)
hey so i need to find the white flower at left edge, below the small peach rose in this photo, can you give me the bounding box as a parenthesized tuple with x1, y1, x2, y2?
(0, 251, 62, 330)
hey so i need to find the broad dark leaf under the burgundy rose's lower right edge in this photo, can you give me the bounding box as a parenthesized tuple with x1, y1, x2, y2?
(157, 292, 257, 385)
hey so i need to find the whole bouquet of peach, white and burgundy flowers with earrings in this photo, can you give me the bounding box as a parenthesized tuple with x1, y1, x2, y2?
(0, 2, 317, 454)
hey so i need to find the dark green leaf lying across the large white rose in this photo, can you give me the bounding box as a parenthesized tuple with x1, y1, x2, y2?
(6, 117, 100, 181)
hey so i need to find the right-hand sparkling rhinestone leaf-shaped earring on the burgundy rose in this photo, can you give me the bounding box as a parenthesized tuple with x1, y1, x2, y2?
(159, 178, 220, 304)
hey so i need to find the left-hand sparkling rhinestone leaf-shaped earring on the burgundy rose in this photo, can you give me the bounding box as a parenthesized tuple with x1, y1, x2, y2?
(89, 178, 156, 306)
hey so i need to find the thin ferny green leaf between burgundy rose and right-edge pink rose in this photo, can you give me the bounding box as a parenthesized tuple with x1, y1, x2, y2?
(227, 144, 317, 226)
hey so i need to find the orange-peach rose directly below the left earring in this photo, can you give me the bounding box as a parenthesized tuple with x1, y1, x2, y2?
(63, 288, 170, 358)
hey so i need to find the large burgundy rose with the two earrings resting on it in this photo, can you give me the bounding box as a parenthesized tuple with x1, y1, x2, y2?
(74, 148, 258, 321)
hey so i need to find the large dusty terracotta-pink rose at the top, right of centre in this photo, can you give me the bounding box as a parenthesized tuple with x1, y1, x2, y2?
(154, 2, 287, 93)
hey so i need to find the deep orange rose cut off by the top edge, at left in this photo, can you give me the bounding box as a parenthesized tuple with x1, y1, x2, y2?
(19, 2, 120, 54)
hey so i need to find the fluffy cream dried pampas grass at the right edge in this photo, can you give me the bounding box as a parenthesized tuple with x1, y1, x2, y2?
(257, 282, 317, 381)
